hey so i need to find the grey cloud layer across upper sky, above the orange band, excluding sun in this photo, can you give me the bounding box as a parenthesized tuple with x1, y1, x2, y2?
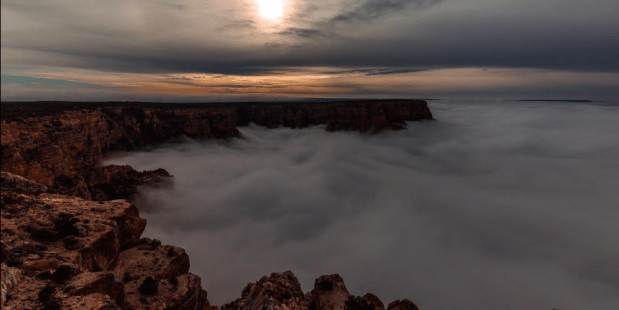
(2, 0, 619, 74)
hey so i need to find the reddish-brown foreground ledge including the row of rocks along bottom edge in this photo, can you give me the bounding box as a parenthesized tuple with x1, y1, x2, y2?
(1, 172, 418, 310)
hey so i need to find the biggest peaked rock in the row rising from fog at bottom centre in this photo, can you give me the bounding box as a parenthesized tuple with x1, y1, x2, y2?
(221, 271, 308, 310)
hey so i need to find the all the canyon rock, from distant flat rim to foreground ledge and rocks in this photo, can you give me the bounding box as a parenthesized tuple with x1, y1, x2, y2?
(1, 100, 432, 310)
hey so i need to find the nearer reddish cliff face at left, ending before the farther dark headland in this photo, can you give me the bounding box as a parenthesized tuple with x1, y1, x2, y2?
(2, 107, 239, 200)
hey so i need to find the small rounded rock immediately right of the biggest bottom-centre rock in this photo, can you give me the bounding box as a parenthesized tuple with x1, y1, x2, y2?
(307, 274, 351, 310)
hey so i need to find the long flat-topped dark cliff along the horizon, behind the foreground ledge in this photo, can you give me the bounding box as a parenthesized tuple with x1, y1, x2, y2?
(1, 100, 432, 200)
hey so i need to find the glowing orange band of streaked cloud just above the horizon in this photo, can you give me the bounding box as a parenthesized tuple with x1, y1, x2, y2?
(23, 68, 617, 97)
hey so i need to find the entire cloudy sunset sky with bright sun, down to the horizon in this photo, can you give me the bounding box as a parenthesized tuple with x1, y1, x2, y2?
(1, 0, 619, 101)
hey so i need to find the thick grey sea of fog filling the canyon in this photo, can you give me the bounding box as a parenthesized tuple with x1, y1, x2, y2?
(108, 100, 619, 310)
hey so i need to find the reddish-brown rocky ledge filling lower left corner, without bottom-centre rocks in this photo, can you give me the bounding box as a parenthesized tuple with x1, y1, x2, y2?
(1, 189, 210, 310)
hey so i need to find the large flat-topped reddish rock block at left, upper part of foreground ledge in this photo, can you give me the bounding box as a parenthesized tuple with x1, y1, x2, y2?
(2, 192, 146, 271)
